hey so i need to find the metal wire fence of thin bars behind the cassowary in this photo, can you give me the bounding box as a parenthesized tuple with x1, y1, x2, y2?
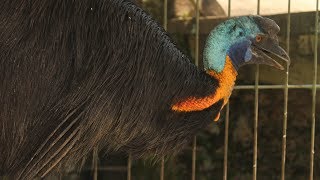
(57, 0, 320, 180)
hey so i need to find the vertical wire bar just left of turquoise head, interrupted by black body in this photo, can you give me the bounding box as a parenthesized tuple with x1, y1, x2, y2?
(191, 0, 199, 180)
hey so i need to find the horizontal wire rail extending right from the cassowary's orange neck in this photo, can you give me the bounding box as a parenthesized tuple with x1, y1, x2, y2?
(234, 84, 320, 90)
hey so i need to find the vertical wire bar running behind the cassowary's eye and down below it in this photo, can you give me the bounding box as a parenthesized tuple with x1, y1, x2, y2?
(252, 0, 260, 180)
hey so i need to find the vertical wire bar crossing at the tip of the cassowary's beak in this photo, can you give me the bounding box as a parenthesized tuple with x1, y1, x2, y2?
(281, 0, 291, 180)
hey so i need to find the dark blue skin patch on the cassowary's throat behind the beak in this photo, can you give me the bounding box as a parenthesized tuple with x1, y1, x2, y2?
(227, 40, 252, 71)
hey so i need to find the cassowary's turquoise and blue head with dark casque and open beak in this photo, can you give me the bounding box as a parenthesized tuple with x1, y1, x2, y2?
(204, 16, 290, 73)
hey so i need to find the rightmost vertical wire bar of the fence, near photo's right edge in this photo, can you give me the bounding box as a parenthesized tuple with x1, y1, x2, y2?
(310, 0, 319, 180)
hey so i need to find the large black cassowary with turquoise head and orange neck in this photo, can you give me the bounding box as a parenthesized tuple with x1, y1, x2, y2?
(0, 0, 289, 179)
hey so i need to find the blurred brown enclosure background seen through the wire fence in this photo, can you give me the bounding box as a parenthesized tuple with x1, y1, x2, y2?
(58, 0, 320, 180)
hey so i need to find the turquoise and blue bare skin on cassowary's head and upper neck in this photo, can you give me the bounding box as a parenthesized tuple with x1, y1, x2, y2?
(203, 16, 261, 73)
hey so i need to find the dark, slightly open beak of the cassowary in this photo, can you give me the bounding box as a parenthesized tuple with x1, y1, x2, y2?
(246, 37, 290, 70)
